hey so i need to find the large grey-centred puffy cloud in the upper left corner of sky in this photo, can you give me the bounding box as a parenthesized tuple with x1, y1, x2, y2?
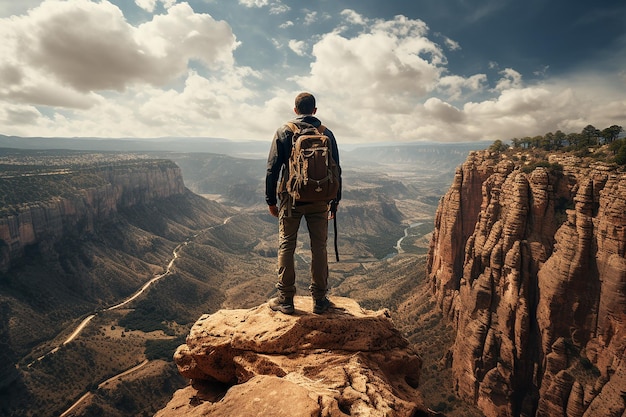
(0, 0, 237, 100)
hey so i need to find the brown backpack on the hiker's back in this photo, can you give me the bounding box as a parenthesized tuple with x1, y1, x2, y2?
(285, 122, 339, 203)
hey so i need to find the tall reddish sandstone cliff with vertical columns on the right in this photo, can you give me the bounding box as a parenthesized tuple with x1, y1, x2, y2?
(428, 151, 626, 417)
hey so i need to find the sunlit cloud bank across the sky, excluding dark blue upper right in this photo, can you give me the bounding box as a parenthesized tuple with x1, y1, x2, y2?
(0, 0, 626, 143)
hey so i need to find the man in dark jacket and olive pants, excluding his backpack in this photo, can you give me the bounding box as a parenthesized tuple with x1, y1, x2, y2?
(265, 93, 341, 314)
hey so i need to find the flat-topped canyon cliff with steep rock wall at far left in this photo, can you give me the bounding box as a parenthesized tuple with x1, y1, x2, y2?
(0, 160, 185, 272)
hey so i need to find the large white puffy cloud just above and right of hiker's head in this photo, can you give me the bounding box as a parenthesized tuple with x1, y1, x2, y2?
(296, 12, 445, 113)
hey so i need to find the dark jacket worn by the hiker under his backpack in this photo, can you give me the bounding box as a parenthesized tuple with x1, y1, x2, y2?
(265, 115, 341, 206)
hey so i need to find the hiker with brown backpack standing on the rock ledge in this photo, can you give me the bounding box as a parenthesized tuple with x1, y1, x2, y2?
(265, 93, 341, 314)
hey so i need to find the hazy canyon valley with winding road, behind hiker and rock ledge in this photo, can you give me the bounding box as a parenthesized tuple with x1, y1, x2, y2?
(0, 145, 458, 417)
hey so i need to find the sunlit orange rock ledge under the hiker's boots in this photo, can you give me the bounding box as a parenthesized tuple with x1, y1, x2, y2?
(157, 297, 433, 417)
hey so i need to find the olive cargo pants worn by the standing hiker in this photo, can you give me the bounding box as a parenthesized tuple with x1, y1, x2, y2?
(276, 201, 328, 300)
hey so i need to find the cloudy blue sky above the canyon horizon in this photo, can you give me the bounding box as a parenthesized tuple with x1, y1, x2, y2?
(0, 0, 626, 143)
